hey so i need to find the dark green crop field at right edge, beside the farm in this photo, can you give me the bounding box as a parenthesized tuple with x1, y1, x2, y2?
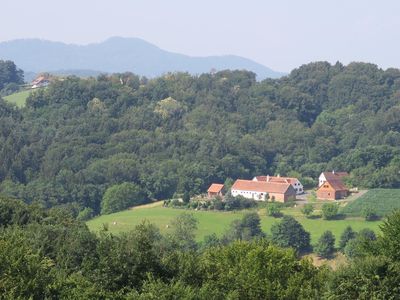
(342, 189, 400, 217)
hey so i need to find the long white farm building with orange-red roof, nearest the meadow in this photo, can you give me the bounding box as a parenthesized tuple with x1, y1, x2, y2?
(231, 179, 296, 202)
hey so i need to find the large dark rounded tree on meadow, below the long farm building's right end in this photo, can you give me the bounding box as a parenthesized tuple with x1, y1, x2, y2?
(271, 216, 311, 252)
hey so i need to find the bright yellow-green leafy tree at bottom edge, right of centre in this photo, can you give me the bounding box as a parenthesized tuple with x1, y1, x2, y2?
(200, 240, 325, 299)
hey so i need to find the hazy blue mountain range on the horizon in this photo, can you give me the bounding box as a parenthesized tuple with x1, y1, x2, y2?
(0, 37, 285, 79)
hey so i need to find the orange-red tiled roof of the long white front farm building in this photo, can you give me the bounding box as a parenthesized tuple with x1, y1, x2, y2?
(231, 179, 293, 194)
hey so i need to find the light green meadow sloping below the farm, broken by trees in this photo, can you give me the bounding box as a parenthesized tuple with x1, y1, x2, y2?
(87, 202, 381, 244)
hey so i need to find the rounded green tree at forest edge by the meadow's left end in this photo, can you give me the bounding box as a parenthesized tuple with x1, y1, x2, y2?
(101, 182, 147, 214)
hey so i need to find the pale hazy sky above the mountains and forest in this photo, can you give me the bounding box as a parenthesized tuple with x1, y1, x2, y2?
(0, 0, 400, 71)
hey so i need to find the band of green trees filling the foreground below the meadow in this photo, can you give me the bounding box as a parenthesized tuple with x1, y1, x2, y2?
(0, 198, 400, 299)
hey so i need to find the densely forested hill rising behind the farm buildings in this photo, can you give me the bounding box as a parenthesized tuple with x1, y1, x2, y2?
(0, 62, 400, 211)
